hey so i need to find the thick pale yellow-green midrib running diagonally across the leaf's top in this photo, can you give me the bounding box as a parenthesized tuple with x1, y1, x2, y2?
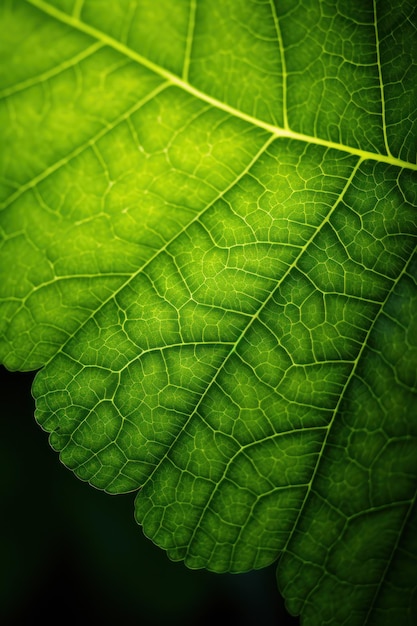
(27, 0, 417, 171)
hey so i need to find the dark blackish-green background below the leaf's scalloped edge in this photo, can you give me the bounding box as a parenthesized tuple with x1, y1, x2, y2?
(0, 368, 299, 626)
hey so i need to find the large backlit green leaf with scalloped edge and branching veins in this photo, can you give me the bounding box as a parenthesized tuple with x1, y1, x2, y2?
(0, 0, 417, 626)
